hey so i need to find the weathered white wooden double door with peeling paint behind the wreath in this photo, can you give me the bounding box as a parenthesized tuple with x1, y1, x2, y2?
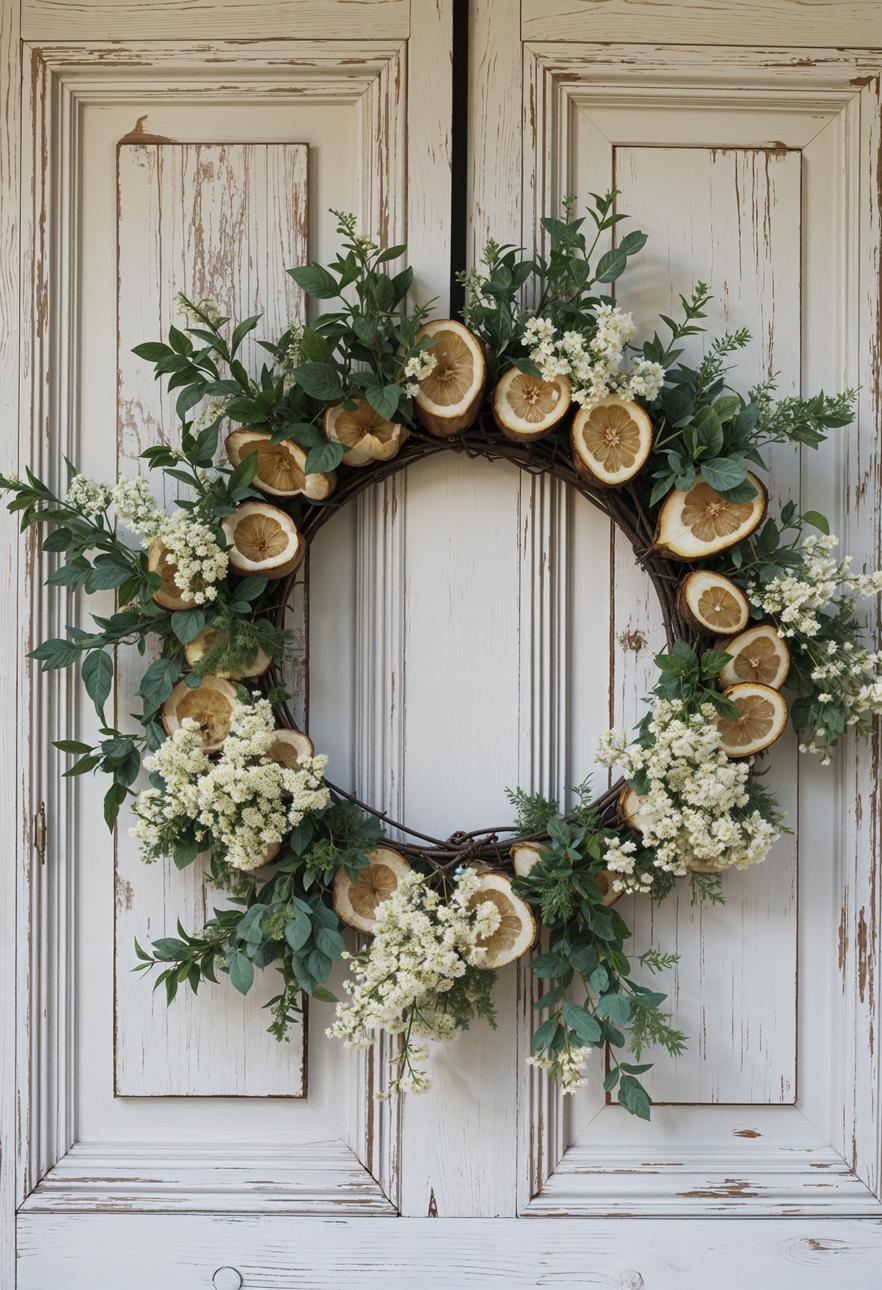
(0, 0, 882, 1290)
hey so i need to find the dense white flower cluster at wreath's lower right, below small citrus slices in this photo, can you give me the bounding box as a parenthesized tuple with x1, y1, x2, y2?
(596, 699, 779, 891)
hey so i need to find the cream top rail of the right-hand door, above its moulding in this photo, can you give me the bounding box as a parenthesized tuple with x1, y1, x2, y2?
(521, 0, 882, 48)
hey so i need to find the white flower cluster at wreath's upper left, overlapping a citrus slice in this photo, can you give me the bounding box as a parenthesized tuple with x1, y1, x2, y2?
(112, 476, 230, 605)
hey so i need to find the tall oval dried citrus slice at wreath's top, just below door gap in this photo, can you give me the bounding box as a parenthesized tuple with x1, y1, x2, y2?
(414, 319, 487, 439)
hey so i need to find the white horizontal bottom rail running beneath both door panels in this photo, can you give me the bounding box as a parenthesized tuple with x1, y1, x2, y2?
(18, 1214, 882, 1290)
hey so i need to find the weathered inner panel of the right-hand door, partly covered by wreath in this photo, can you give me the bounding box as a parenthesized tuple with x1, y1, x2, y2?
(606, 141, 801, 1103)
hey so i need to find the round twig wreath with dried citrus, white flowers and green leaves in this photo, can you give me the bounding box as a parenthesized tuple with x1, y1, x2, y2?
(0, 192, 882, 1117)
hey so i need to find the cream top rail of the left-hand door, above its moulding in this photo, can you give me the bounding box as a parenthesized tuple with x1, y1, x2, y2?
(22, 0, 410, 41)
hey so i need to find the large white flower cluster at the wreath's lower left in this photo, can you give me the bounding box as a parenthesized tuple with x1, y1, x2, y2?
(132, 694, 329, 869)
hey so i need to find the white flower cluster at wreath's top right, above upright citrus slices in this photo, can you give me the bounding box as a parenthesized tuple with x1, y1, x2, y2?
(522, 304, 664, 408)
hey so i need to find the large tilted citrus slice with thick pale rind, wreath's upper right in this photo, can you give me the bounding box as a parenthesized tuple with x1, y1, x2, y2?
(655, 475, 769, 560)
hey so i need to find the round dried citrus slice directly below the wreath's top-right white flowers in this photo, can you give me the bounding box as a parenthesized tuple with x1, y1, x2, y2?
(570, 395, 652, 488)
